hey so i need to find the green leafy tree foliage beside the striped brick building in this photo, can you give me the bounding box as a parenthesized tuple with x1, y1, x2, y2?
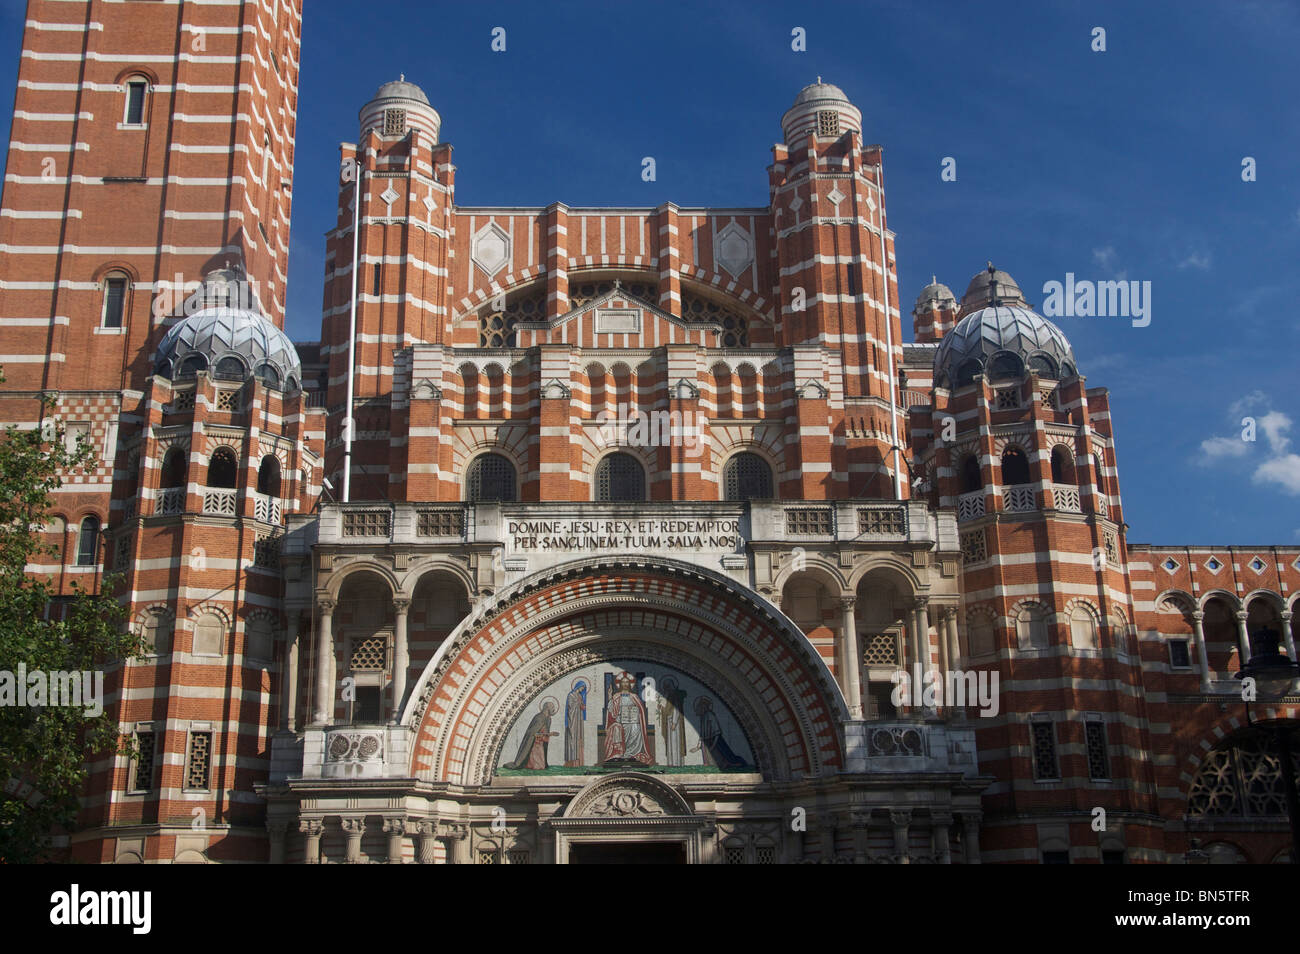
(0, 374, 143, 863)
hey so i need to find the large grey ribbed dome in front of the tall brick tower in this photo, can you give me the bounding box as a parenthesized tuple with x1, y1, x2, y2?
(153, 305, 303, 391)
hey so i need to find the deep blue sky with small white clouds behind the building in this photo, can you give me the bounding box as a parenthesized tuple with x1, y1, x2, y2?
(0, 0, 1300, 545)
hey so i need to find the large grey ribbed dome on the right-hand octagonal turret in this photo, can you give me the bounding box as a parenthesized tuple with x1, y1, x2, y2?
(935, 305, 1078, 387)
